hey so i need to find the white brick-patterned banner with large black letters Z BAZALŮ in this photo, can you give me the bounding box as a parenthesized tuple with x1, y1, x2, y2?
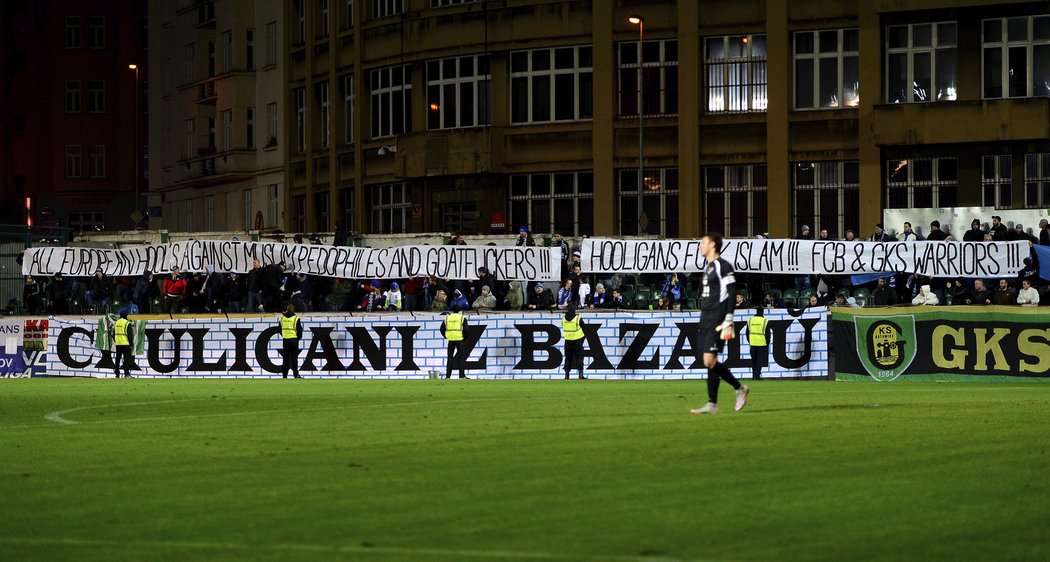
(38, 308, 828, 379)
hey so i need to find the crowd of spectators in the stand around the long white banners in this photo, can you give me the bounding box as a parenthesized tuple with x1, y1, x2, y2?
(16, 216, 1050, 314)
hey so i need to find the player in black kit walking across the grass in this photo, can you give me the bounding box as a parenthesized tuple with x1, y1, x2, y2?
(690, 232, 750, 414)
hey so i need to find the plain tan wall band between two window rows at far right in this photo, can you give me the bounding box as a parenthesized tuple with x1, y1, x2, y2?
(874, 98, 1050, 146)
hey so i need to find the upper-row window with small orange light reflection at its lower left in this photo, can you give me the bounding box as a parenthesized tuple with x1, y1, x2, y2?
(426, 55, 491, 130)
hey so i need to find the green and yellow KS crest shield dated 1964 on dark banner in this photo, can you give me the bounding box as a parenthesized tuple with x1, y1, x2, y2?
(855, 315, 916, 381)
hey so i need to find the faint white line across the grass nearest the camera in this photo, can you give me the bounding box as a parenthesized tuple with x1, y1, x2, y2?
(0, 537, 705, 562)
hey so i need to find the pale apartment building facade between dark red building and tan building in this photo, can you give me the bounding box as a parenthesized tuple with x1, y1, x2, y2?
(149, 0, 287, 231)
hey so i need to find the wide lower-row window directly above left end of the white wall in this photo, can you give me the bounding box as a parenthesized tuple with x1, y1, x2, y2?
(886, 158, 959, 209)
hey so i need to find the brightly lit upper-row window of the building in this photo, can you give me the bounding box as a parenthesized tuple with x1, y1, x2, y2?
(704, 35, 769, 113)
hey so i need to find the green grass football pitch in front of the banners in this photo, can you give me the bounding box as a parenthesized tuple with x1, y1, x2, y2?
(0, 379, 1050, 562)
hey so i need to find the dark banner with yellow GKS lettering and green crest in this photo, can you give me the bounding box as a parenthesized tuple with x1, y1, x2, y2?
(832, 306, 1050, 381)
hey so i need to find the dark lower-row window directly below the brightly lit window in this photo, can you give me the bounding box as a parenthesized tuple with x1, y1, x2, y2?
(702, 164, 770, 237)
